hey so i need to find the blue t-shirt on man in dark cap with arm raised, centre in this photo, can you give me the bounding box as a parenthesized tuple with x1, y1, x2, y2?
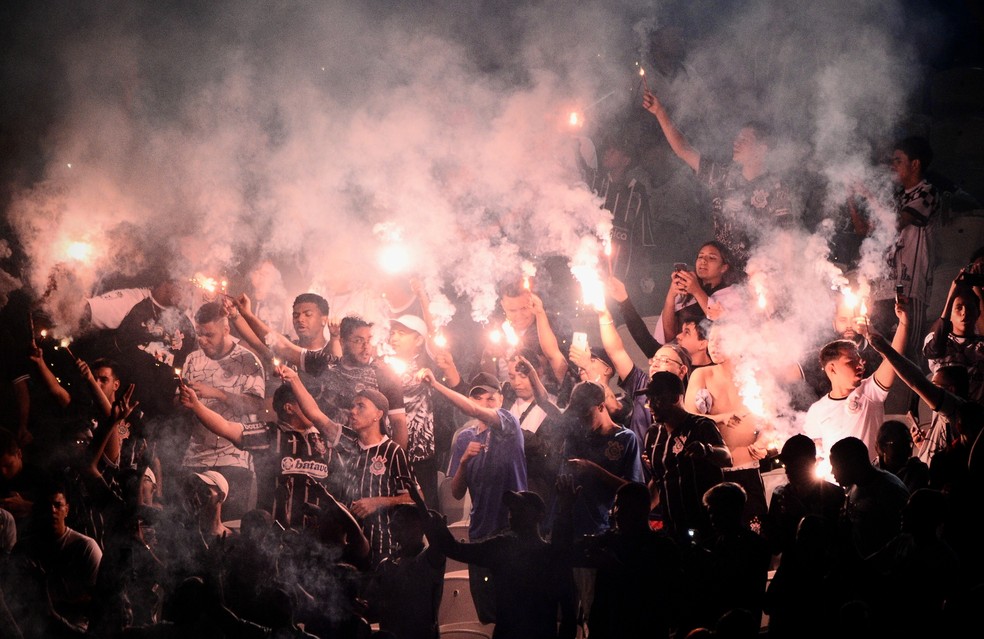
(448, 408, 526, 540)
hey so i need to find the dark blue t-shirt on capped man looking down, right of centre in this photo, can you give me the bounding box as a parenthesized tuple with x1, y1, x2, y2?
(564, 426, 645, 535)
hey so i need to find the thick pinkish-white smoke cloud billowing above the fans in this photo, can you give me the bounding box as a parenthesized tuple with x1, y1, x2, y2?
(3, 0, 934, 432)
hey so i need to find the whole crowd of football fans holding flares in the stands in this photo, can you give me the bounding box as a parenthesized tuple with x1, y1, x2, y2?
(0, 86, 984, 639)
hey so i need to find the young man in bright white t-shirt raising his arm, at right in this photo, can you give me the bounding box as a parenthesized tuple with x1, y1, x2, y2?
(803, 300, 909, 451)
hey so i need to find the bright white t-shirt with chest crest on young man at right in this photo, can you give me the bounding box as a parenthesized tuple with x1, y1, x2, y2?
(803, 375, 888, 458)
